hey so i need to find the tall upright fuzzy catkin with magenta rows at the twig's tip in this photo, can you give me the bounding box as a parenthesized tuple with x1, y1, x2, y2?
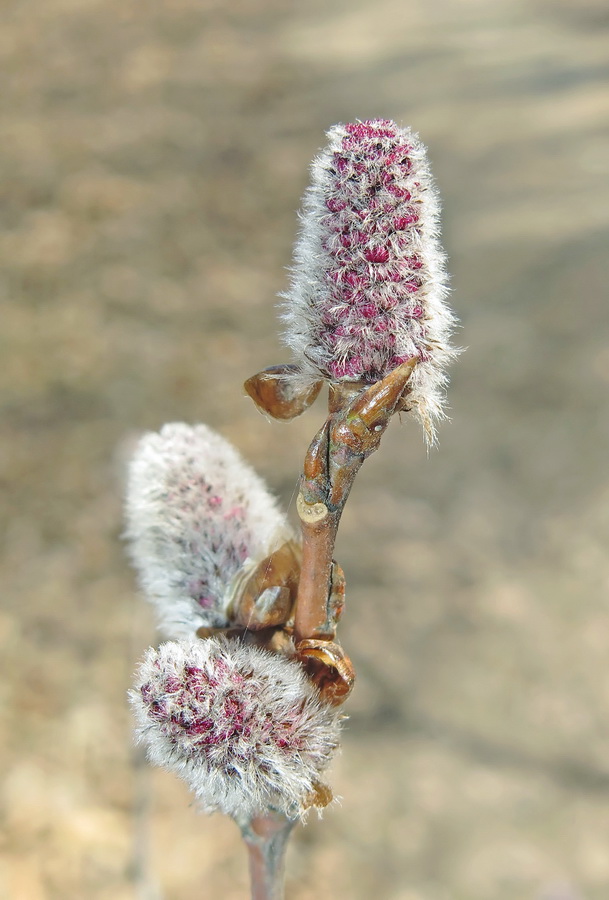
(283, 119, 454, 437)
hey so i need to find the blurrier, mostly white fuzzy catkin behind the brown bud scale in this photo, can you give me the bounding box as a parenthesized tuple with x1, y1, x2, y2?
(125, 423, 291, 638)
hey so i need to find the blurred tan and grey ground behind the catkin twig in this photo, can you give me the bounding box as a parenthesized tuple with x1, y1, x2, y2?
(0, 0, 609, 900)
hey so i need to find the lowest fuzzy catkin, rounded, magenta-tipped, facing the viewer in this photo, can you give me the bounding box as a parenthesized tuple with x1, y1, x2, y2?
(130, 638, 341, 819)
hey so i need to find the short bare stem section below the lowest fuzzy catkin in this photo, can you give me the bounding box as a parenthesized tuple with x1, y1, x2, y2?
(238, 812, 296, 900)
